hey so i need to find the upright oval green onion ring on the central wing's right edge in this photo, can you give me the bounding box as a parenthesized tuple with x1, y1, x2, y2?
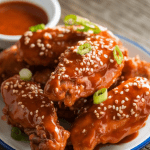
(113, 45, 123, 64)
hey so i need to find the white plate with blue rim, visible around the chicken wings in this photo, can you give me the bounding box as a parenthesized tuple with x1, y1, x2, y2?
(0, 35, 150, 150)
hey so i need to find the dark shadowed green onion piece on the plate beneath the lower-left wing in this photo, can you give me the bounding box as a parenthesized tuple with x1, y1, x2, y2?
(11, 127, 29, 141)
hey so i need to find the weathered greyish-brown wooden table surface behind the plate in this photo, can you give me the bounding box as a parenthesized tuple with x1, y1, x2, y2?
(59, 0, 150, 150)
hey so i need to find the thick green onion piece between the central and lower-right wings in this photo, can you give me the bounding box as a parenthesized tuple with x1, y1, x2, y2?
(93, 88, 108, 104)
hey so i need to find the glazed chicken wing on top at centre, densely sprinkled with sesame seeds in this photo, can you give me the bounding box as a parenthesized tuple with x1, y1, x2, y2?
(44, 27, 127, 107)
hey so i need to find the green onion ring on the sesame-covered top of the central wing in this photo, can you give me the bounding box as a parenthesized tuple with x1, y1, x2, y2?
(77, 43, 92, 55)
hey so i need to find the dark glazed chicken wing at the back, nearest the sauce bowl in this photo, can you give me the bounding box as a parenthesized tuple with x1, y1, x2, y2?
(18, 26, 87, 66)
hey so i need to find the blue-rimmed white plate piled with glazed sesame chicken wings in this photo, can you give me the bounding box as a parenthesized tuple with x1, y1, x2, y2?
(0, 16, 150, 150)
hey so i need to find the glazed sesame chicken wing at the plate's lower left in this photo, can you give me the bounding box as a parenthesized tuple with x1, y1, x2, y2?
(1, 75, 69, 150)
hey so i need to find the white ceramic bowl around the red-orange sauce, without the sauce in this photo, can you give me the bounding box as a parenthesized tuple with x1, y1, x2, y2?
(0, 0, 61, 49)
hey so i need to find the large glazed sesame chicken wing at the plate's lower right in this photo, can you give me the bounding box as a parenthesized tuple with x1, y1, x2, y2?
(71, 77, 150, 150)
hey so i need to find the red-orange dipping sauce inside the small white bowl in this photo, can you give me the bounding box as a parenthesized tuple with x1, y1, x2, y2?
(0, 1, 48, 35)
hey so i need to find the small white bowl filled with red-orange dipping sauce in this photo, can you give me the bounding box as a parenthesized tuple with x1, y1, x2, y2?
(0, 0, 61, 49)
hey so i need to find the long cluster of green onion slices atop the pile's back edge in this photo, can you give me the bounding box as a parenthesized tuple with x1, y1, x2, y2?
(64, 14, 101, 34)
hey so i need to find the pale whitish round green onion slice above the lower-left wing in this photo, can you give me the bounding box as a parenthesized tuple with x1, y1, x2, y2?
(19, 68, 32, 81)
